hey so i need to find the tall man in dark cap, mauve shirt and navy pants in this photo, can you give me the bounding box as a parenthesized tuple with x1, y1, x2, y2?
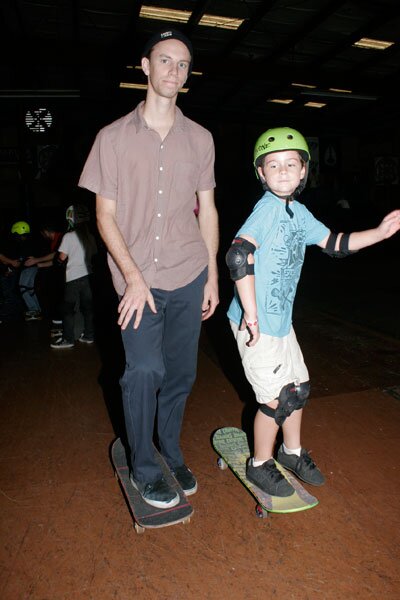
(79, 29, 218, 508)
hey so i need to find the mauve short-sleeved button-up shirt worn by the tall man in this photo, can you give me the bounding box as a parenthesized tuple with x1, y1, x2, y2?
(78, 102, 215, 295)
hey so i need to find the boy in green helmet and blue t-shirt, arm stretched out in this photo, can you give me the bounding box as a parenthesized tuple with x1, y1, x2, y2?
(226, 127, 400, 496)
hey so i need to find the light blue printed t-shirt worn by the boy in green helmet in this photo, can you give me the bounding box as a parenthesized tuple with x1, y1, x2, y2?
(228, 192, 329, 337)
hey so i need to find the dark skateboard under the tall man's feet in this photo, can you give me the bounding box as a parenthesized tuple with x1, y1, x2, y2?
(111, 438, 194, 534)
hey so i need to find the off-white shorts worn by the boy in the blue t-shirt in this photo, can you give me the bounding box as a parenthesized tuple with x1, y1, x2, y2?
(230, 321, 309, 404)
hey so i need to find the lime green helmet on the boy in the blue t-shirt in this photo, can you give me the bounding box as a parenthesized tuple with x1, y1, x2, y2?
(253, 127, 310, 196)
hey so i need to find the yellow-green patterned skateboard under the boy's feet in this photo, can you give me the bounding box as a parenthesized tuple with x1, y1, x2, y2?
(212, 427, 318, 518)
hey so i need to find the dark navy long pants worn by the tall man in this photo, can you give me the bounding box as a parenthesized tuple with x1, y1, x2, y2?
(120, 270, 207, 483)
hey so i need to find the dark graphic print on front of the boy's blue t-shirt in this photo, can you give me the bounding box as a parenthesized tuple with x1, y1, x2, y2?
(265, 221, 306, 315)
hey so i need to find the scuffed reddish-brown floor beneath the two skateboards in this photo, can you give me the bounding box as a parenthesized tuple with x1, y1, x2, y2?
(0, 245, 400, 600)
